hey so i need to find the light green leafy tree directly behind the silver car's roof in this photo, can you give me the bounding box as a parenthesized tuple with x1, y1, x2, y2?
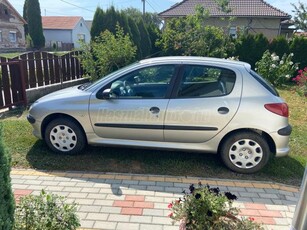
(157, 6, 230, 57)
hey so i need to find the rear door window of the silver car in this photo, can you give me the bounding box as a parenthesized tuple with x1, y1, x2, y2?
(177, 65, 236, 98)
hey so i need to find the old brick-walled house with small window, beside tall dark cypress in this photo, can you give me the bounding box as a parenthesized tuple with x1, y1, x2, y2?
(0, 0, 26, 52)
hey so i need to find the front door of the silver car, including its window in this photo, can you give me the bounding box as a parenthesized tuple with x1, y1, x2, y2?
(89, 65, 176, 141)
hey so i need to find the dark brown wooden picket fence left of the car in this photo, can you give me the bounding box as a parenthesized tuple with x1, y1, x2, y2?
(0, 51, 83, 109)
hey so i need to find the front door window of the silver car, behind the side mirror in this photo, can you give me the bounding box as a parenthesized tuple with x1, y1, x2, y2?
(103, 65, 175, 99)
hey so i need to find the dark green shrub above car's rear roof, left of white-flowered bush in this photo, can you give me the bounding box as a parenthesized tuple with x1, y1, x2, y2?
(235, 34, 269, 68)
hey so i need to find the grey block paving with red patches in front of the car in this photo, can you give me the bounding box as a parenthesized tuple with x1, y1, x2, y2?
(11, 169, 299, 230)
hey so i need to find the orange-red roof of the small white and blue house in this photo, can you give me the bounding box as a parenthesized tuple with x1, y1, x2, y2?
(42, 16, 82, 30)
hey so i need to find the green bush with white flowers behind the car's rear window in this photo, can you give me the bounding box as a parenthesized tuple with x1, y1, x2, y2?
(256, 50, 298, 86)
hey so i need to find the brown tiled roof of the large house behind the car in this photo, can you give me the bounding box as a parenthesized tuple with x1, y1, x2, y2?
(159, 0, 291, 19)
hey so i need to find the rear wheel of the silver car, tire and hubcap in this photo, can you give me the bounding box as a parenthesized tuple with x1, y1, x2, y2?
(220, 131, 271, 173)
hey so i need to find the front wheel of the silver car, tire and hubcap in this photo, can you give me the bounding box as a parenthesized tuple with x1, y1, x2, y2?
(45, 118, 86, 155)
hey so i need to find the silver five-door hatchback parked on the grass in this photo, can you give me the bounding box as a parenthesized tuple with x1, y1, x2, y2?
(28, 57, 291, 173)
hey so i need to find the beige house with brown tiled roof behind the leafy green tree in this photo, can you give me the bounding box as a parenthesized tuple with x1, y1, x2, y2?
(158, 0, 291, 39)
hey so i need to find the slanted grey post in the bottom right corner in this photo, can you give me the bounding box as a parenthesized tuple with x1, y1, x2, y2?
(291, 166, 307, 230)
